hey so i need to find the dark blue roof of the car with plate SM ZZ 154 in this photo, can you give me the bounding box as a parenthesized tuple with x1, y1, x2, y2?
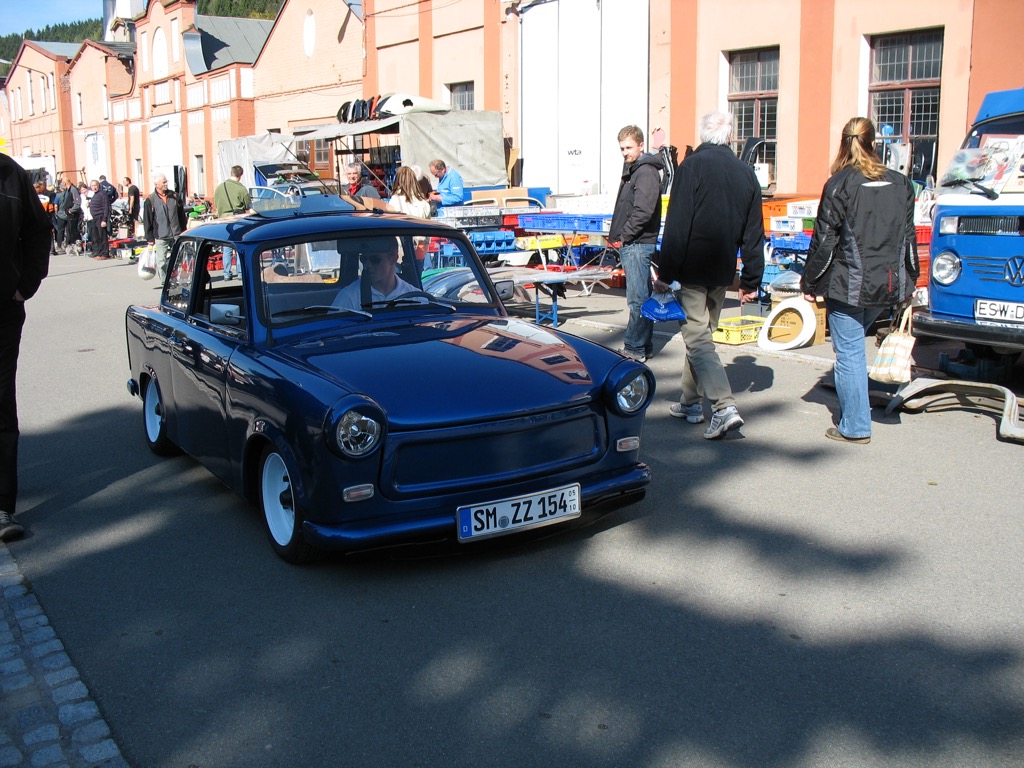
(183, 196, 463, 244)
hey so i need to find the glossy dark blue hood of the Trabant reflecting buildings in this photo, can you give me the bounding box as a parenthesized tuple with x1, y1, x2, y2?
(274, 315, 606, 426)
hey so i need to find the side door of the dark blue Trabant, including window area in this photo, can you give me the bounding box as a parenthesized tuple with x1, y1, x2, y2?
(167, 240, 247, 484)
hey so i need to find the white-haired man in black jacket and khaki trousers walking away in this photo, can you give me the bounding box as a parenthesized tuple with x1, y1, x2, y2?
(654, 112, 765, 439)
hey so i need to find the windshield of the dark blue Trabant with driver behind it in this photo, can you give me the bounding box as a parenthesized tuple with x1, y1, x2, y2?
(257, 228, 499, 326)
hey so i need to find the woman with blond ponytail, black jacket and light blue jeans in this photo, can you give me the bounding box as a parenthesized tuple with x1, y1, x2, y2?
(800, 118, 919, 443)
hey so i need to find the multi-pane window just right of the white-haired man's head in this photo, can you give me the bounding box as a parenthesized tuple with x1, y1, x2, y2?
(729, 48, 778, 181)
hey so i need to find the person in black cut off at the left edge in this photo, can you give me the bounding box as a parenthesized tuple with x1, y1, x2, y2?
(0, 154, 50, 542)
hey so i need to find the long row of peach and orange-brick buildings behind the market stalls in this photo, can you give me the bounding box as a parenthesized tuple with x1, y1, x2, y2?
(0, 0, 1024, 196)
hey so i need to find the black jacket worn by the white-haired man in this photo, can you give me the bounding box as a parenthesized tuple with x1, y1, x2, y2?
(657, 143, 765, 291)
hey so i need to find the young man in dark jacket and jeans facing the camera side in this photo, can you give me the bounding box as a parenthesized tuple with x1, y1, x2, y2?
(608, 125, 663, 362)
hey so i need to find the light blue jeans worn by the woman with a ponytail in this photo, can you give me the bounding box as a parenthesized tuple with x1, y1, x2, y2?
(825, 299, 882, 437)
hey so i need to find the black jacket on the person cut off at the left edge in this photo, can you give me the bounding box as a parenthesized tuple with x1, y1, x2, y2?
(0, 154, 52, 301)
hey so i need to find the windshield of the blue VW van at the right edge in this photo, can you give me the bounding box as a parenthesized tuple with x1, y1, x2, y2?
(939, 115, 1024, 195)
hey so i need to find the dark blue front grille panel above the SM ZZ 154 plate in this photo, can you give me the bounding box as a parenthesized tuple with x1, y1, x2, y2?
(382, 406, 606, 497)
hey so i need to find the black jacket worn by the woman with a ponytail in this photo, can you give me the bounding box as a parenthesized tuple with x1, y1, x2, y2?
(800, 166, 920, 307)
